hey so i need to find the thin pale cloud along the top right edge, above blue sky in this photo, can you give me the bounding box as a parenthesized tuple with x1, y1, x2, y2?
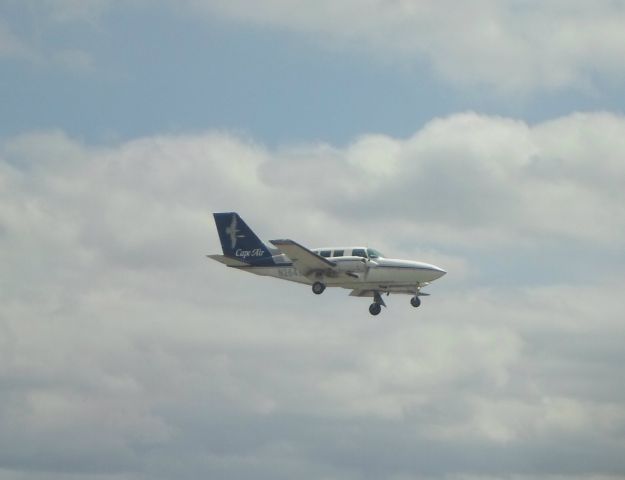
(189, 0, 625, 94)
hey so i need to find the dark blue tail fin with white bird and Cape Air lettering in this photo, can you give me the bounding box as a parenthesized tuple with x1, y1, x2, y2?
(213, 212, 273, 265)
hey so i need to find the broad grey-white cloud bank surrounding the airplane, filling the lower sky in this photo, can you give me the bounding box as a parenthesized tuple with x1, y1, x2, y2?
(0, 113, 625, 480)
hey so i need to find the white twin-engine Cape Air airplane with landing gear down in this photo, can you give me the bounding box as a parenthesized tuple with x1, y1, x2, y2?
(207, 212, 447, 315)
